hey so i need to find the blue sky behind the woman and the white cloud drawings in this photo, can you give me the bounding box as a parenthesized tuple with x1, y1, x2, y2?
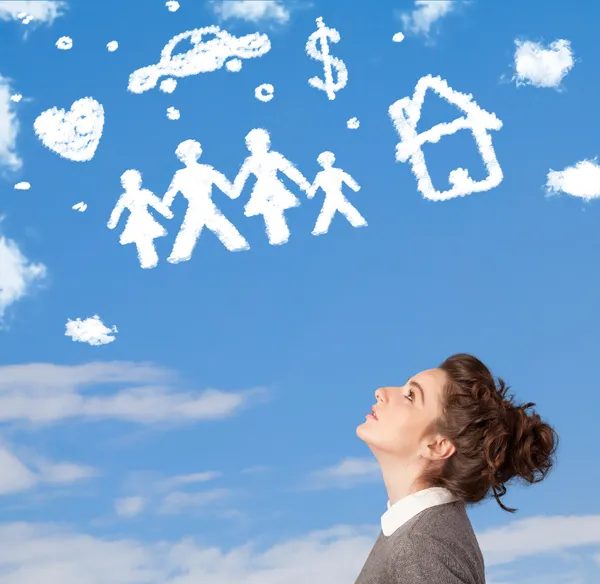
(0, 0, 600, 584)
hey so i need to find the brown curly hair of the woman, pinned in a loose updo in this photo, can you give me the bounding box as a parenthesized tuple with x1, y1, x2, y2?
(420, 353, 558, 513)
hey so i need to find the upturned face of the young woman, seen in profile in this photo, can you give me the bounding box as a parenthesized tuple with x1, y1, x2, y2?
(356, 369, 446, 462)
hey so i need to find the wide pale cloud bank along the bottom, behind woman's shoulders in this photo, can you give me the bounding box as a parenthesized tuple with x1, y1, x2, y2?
(0, 515, 600, 584)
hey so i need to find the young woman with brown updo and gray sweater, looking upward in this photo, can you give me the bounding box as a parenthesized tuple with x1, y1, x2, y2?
(356, 353, 558, 584)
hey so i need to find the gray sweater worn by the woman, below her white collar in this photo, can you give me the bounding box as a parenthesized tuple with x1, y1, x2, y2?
(355, 501, 485, 584)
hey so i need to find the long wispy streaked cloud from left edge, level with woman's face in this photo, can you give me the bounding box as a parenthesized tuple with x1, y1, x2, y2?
(0, 360, 266, 424)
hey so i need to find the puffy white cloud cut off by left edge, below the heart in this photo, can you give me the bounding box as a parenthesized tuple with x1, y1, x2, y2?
(0, 221, 46, 323)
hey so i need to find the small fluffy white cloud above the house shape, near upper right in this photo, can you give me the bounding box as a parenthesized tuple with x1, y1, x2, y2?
(513, 39, 575, 87)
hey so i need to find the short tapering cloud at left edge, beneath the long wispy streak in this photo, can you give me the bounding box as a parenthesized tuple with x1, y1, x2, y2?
(0, 446, 98, 495)
